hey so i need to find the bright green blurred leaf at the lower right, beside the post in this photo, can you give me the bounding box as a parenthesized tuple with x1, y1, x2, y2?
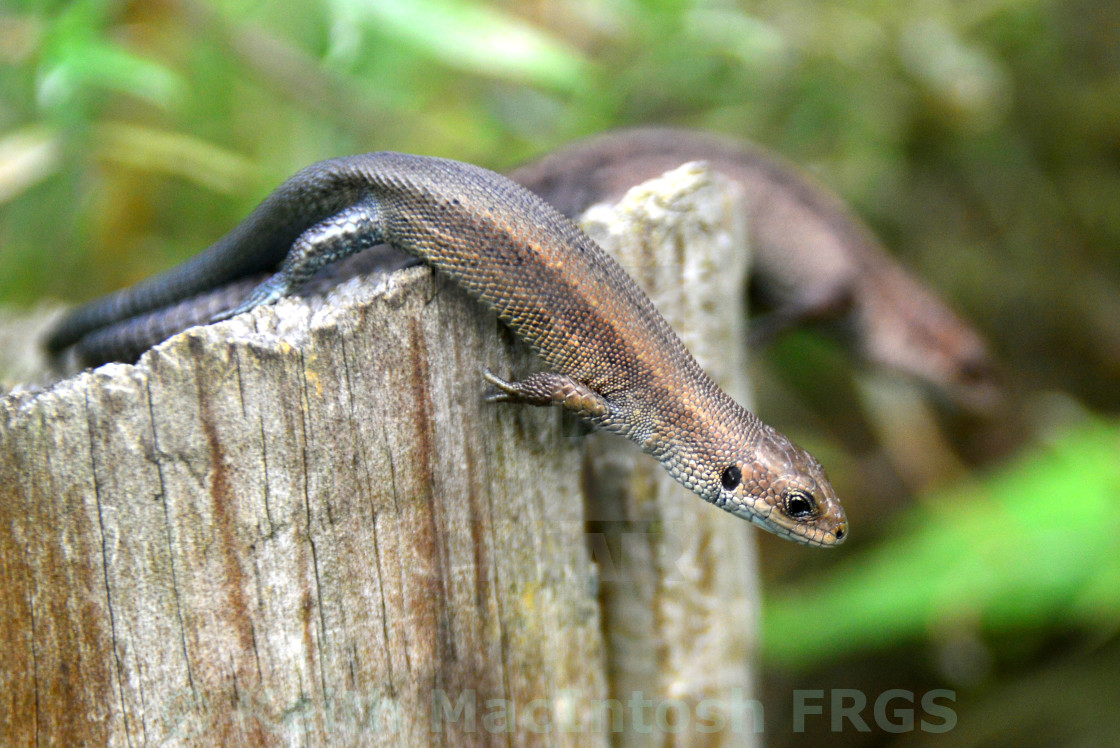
(763, 422, 1120, 666)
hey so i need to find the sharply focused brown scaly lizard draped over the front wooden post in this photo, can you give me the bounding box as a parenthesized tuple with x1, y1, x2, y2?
(43, 152, 847, 546)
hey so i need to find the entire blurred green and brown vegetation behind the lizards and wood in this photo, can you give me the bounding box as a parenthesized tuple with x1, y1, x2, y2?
(0, 0, 1120, 746)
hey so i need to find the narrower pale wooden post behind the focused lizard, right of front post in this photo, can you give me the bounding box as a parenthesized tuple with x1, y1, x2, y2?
(582, 165, 762, 746)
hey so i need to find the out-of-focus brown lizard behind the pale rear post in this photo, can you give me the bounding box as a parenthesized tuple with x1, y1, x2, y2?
(510, 128, 998, 409)
